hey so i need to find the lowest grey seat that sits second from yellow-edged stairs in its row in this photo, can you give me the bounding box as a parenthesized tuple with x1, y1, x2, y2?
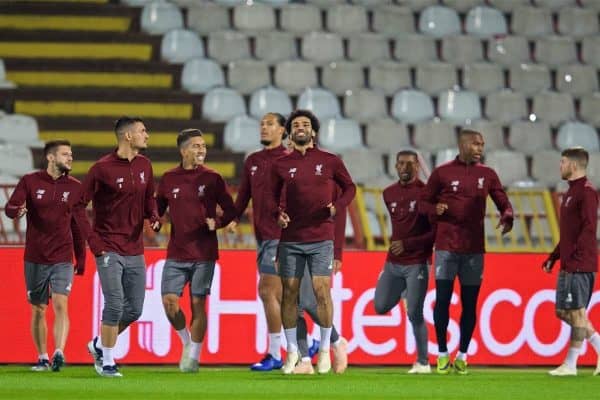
(227, 58, 271, 94)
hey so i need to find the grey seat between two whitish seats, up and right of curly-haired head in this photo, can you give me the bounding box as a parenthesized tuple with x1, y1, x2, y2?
(344, 89, 387, 123)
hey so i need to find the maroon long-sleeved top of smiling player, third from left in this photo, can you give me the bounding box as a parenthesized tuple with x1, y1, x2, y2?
(156, 166, 236, 261)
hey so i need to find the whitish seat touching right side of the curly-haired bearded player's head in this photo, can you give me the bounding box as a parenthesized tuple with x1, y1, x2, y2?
(319, 117, 363, 153)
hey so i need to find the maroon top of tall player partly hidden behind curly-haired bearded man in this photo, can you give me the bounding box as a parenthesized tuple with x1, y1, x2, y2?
(235, 146, 287, 240)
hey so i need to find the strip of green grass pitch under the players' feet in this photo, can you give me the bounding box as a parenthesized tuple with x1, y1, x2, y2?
(0, 365, 600, 400)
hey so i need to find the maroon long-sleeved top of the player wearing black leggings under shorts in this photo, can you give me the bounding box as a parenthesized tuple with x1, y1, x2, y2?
(422, 157, 513, 253)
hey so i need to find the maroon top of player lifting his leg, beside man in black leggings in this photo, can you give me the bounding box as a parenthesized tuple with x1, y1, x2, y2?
(383, 180, 435, 265)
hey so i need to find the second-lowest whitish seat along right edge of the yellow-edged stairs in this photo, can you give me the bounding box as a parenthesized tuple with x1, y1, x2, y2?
(202, 88, 246, 122)
